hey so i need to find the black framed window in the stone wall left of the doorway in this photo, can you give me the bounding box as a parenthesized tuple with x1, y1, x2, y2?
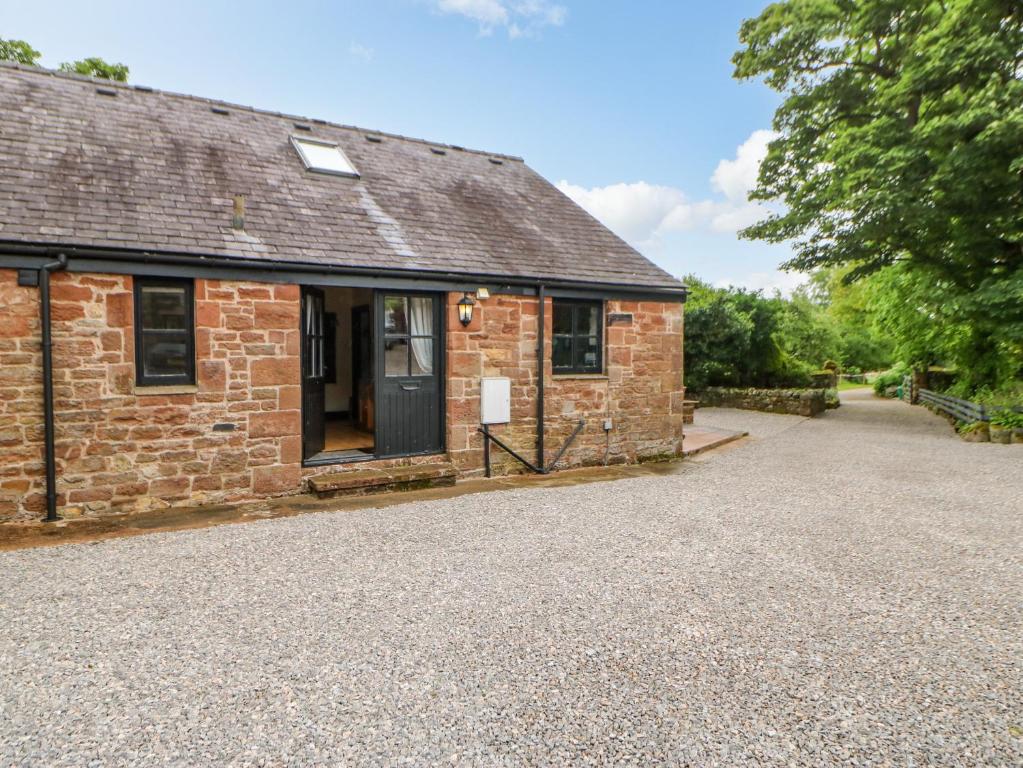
(135, 277, 195, 387)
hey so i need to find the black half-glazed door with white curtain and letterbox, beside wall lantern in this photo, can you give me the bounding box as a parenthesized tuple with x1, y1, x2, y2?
(374, 290, 444, 457)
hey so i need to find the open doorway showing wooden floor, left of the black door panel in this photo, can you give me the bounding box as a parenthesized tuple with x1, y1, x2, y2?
(302, 287, 375, 463)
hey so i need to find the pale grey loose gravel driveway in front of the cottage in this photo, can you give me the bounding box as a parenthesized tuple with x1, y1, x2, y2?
(0, 393, 1023, 766)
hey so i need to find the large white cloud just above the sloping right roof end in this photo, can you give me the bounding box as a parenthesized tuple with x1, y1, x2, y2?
(558, 126, 774, 246)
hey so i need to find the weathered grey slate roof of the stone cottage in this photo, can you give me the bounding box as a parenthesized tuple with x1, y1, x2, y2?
(0, 64, 681, 289)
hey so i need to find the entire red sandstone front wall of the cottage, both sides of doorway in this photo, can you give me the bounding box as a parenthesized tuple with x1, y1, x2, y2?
(0, 270, 684, 519)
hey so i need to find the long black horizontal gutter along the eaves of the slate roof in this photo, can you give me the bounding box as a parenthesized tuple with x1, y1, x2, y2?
(0, 240, 687, 301)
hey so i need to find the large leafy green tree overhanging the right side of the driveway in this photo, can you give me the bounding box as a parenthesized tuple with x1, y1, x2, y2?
(733, 0, 1023, 390)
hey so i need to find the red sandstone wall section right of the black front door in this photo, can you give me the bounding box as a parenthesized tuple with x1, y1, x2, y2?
(447, 293, 684, 475)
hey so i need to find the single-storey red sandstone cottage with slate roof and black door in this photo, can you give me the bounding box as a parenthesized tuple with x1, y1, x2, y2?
(0, 64, 685, 519)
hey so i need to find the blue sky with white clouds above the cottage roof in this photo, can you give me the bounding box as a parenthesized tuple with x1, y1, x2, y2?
(0, 0, 800, 288)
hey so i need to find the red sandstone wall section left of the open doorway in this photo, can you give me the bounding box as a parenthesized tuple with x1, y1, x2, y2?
(0, 270, 302, 519)
